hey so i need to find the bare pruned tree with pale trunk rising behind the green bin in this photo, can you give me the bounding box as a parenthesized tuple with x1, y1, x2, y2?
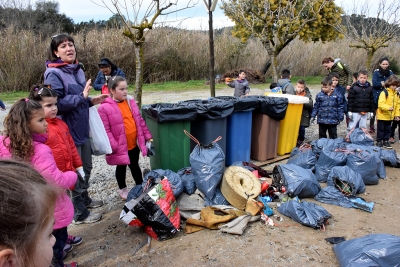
(93, 0, 197, 107)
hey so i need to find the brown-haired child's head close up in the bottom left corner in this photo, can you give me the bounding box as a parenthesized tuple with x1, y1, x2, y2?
(0, 160, 59, 267)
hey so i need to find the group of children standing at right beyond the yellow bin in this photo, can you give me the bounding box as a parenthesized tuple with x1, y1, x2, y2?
(270, 57, 400, 149)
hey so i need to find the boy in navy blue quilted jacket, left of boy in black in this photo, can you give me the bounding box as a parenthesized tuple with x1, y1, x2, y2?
(311, 77, 343, 139)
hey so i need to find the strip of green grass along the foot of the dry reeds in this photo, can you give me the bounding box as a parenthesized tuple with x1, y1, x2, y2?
(0, 76, 322, 102)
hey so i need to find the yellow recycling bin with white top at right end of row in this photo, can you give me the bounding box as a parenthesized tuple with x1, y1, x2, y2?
(268, 94, 309, 156)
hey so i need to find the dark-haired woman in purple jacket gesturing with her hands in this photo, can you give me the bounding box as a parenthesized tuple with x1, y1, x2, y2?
(44, 34, 107, 226)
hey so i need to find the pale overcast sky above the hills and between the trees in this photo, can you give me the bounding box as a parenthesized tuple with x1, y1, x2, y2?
(52, 0, 398, 30)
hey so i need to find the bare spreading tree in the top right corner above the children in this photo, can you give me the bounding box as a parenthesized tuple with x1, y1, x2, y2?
(338, 0, 400, 70)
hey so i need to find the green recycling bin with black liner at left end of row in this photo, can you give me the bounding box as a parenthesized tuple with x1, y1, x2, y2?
(142, 103, 197, 172)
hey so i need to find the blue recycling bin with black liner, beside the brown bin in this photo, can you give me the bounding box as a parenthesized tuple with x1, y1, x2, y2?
(216, 96, 259, 166)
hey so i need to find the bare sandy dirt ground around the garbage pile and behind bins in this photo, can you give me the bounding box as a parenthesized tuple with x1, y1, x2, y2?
(65, 90, 400, 267)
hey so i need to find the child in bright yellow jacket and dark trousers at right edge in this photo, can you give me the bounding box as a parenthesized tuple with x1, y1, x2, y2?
(376, 75, 400, 149)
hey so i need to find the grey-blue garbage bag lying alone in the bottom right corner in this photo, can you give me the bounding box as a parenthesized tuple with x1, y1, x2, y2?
(332, 234, 400, 267)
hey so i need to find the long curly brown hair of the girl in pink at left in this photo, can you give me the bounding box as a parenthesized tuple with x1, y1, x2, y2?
(3, 98, 43, 161)
